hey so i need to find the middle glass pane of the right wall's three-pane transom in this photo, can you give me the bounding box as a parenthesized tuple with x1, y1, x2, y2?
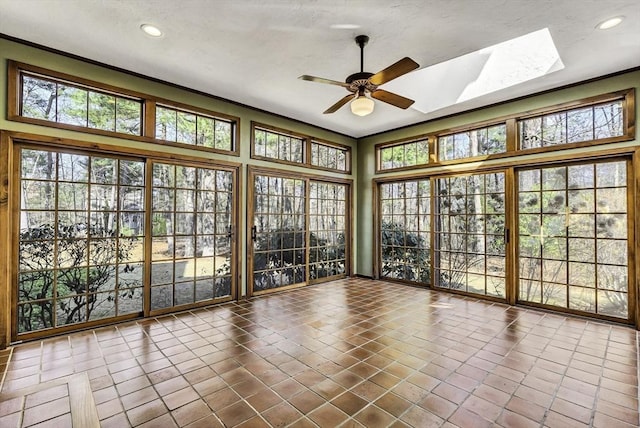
(438, 124, 507, 161)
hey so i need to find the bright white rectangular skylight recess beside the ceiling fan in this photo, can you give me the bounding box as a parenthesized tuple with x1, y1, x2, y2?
(385, 28, 564, 113)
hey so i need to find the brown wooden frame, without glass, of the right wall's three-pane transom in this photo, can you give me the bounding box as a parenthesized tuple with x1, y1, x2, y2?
(375, 88, 636, 174)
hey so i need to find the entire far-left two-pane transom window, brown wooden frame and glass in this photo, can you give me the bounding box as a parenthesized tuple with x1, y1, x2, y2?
(7, 61, 240, 156)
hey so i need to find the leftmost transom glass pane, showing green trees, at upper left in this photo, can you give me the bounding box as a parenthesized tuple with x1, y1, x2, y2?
(20, 72, 142, 135)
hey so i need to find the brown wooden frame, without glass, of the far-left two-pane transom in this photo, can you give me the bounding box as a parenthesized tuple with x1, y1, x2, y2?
(7, 60, 240, 157)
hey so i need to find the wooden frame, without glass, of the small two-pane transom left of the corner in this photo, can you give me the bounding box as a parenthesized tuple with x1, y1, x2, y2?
(250, 121, 352, 175)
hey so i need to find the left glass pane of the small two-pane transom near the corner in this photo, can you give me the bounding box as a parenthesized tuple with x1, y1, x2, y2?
(253, 127, 304, 163)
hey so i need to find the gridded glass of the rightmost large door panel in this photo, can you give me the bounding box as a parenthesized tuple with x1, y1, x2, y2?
(518, 161, 629, 319)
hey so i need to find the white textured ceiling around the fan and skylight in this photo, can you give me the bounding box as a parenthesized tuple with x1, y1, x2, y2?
(0, 0, 640, 137)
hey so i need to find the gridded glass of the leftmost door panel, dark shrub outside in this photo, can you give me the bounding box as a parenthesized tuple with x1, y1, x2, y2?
(16, 149, 145, 334)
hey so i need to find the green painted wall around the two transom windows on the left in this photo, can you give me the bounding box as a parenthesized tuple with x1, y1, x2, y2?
(0, 38, 358, 300)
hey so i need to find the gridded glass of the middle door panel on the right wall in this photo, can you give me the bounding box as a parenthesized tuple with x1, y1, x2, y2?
(434, 172, 506, 298)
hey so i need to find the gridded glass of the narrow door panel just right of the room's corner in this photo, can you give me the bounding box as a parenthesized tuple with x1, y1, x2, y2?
(380, 179, 431, 285)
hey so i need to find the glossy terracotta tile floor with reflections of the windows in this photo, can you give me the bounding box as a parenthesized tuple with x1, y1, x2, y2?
(0, 278, 639, 428)
